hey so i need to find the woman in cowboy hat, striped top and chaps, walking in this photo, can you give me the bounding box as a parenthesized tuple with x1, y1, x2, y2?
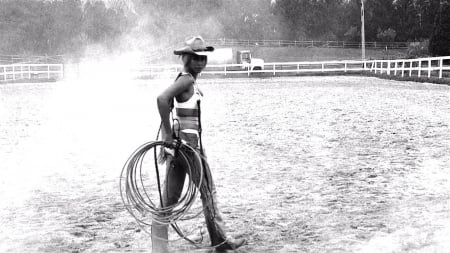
(152, 36, 245, 253)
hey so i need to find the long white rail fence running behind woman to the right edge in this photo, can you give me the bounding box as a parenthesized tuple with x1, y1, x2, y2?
(137, 56, 450, 78)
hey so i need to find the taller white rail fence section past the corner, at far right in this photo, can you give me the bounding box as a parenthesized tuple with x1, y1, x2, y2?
(369, 56, 450, 78)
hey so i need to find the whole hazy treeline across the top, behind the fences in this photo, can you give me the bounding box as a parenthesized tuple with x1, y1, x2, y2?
(0, 0, 450, 55)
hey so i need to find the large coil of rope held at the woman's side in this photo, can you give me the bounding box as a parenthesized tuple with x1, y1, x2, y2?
(120, 141, 203, 226)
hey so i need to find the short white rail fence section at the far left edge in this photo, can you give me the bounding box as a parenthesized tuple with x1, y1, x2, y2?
(0, 64, 64, 81)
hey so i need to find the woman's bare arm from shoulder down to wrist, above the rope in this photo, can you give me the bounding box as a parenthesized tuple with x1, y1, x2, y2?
(157, 75, 194, 142)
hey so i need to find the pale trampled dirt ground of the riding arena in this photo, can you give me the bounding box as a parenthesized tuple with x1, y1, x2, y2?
(0, 76, 450, 252)
